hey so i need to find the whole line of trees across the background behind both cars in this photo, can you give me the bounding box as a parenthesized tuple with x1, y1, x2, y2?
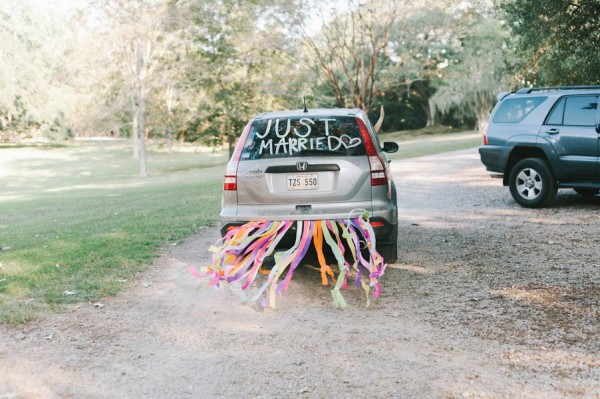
(0, 0, 600, 167)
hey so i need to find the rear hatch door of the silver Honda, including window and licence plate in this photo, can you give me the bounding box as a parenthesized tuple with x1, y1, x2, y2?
(237, 115, 372, 212)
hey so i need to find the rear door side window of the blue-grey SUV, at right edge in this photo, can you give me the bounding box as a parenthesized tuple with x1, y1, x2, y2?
(546, 96, 598, 126)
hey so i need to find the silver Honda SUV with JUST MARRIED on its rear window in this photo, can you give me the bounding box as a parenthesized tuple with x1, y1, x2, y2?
(220, 109, 398, 263)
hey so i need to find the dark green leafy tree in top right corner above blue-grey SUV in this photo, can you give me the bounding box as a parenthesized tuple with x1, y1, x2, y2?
(502, 0, 600, 85)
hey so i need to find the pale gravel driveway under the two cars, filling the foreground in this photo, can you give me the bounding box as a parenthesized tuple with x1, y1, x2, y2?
(0, 150, 600, 399)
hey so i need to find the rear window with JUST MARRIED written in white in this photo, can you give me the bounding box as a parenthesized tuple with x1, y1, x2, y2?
(241, 115, 366, 160)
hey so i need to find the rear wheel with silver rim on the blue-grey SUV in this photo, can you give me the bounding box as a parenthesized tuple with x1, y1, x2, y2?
(508, 158, 558, 208)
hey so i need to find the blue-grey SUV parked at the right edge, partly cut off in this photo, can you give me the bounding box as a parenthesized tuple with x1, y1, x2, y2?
(479, 86, 600, 208)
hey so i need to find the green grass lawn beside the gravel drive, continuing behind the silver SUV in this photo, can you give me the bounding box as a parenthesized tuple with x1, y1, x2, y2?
(0, 132, 481, 323)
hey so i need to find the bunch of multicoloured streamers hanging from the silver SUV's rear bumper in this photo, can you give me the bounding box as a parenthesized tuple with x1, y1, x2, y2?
(190, 210, 387, 308)
